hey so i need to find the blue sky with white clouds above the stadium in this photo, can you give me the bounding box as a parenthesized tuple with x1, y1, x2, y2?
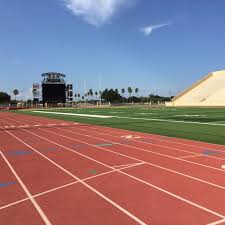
(0, 0, 225, 96)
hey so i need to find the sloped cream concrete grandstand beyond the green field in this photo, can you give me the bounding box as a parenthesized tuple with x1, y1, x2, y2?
(166, 70, 225, 106)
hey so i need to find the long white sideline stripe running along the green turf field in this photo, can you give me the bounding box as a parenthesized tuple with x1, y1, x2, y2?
(31, 111, 225, 127)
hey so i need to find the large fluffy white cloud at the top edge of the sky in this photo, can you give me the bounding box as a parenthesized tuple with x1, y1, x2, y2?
(63, 0, 137, 26)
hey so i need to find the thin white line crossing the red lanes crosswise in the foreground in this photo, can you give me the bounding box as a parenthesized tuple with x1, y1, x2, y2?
(0, 163, 144, 210)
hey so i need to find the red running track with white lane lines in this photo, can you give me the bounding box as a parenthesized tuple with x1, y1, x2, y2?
(0, 112, 225, 225)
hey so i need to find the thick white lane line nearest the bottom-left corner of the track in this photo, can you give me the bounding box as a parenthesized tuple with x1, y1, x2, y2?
(0, 151, 51, 225)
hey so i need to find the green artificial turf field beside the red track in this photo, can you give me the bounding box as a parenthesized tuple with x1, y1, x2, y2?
(14, 107, 225, 144)
